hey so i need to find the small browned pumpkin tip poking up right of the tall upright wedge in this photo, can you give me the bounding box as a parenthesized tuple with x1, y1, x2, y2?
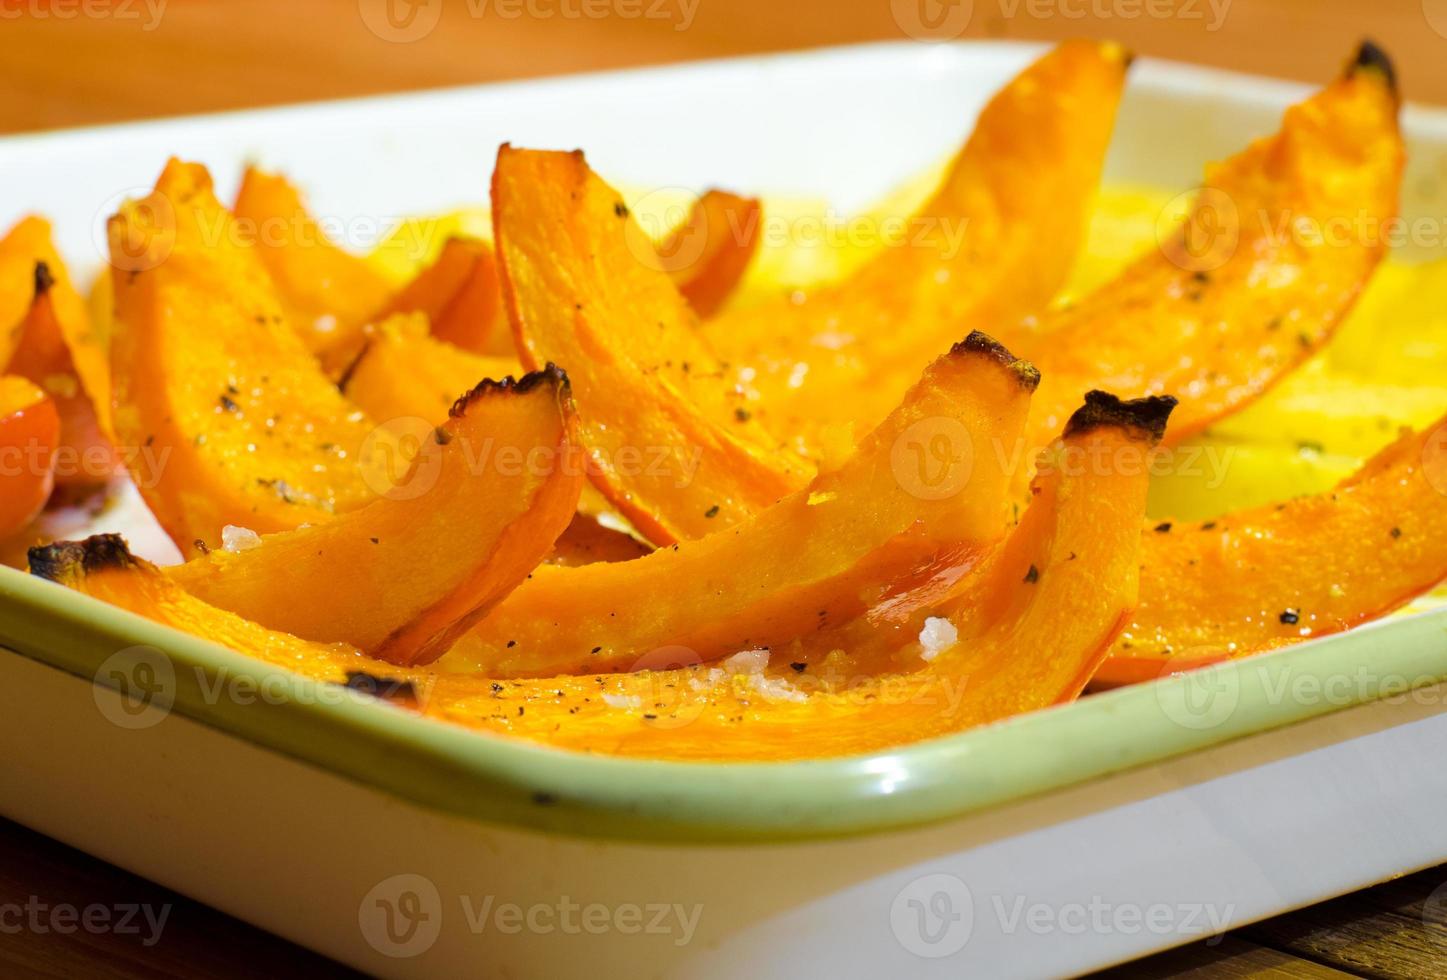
(655, 188, 763, 317)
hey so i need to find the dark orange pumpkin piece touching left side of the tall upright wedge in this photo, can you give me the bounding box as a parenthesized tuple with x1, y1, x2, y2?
(379, 237, 512, 355)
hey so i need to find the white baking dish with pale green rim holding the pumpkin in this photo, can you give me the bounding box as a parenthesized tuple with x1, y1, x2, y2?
(0, 43, 1447, 977)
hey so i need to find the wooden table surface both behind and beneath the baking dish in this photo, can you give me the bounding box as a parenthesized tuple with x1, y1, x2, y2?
(0, 0, 1447, 977)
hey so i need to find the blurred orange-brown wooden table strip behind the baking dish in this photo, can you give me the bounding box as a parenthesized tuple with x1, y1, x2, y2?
(0, 0, 1447, 132)
